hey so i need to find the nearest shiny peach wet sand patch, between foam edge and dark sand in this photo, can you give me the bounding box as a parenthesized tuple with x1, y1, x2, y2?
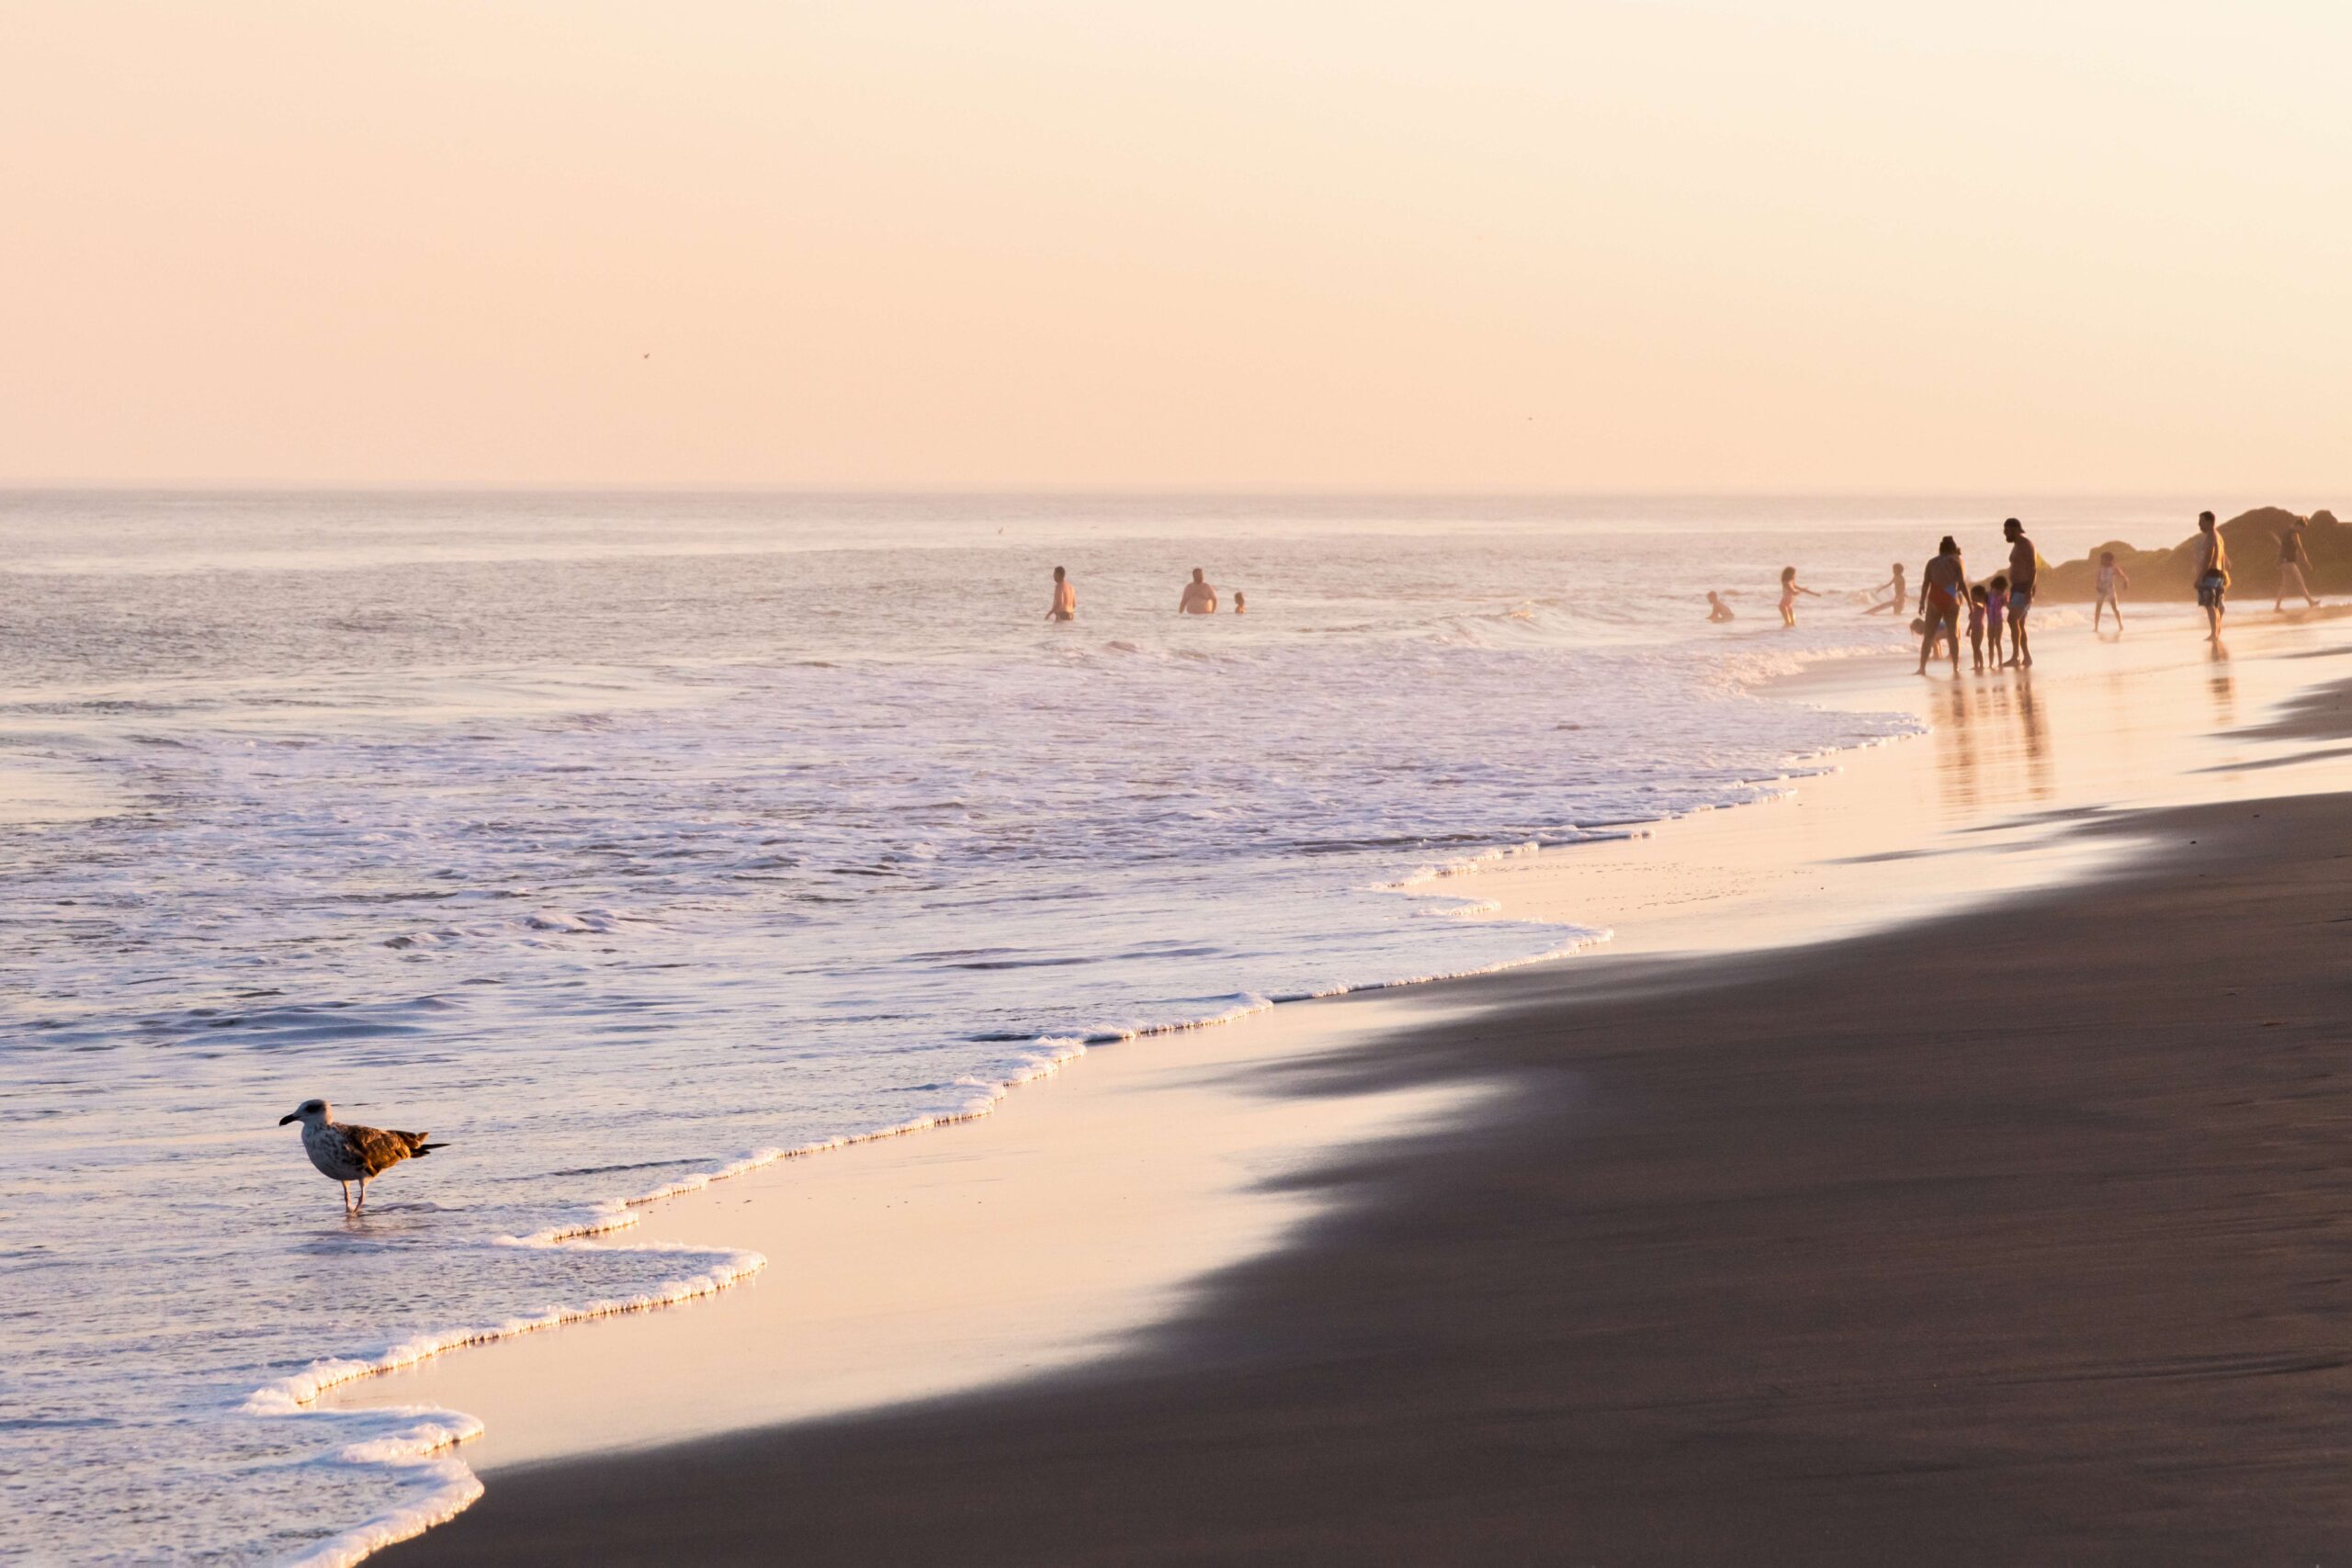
(322, 992, 1487, 1479)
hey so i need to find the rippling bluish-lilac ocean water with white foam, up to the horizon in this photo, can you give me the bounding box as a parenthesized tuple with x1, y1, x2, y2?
(0, 493, 2180, 1563)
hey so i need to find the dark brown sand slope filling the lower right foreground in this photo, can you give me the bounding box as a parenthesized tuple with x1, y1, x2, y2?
(388, 719, 2352, 1568)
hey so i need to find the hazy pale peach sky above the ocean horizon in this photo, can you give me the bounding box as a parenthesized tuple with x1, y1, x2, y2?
(0, 0, 2352, 491)
